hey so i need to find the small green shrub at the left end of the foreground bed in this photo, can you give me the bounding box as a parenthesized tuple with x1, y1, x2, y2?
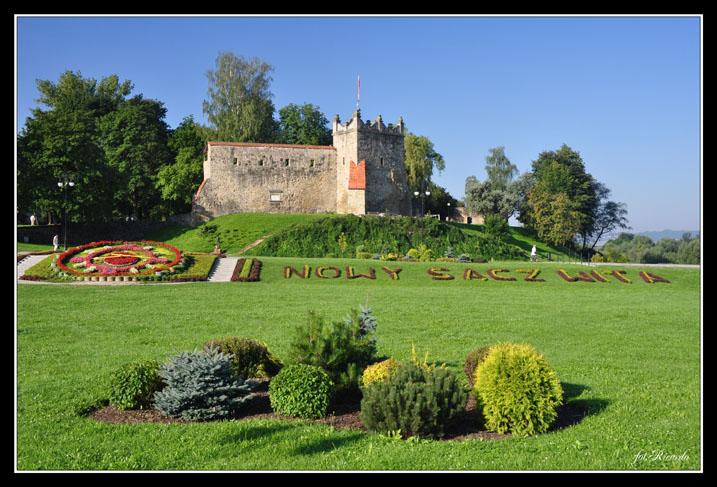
(109, 360, 164, 410)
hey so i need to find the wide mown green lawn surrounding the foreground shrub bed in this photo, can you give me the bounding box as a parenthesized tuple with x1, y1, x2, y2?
(16, 257, 702, 470)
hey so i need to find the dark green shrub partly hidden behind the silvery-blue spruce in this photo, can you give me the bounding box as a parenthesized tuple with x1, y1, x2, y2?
(203, 337, 284, 379)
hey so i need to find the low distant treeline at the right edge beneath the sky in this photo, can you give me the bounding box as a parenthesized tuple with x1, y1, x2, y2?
(598, 232, 700, 264)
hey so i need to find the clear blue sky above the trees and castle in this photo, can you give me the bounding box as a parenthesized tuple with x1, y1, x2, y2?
(16, 15, 702, 232)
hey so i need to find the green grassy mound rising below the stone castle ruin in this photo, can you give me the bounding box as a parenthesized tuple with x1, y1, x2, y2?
(17, 213, 568, 261)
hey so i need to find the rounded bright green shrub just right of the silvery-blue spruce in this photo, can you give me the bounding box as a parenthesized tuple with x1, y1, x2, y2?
(269, 364, 334, 419)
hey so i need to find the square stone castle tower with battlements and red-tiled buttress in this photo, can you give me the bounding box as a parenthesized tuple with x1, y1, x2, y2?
(333, 109, 411, 215)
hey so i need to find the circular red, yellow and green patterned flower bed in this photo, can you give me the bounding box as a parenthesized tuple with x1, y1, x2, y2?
(57, 241, 182, 276)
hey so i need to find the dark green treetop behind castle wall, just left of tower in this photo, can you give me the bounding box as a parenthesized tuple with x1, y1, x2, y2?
(279, 103, 332, 145)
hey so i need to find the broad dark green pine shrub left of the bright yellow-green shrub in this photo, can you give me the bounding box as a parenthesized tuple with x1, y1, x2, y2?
(360, 363, 467, 439)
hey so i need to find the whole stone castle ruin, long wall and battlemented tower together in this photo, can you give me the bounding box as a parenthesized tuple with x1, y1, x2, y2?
(191, 109, 412, 224)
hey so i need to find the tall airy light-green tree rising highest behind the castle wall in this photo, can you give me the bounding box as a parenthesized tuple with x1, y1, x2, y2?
(203, 51, 278, 142)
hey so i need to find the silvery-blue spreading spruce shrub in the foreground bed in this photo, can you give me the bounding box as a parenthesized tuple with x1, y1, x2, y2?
(154, 347, 251, 421)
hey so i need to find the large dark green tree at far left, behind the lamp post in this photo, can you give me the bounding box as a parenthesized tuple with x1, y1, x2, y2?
(17, 71, 132, 221)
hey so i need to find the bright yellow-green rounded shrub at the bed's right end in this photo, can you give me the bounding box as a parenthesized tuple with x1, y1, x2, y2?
(473, 343, 563, 436)
